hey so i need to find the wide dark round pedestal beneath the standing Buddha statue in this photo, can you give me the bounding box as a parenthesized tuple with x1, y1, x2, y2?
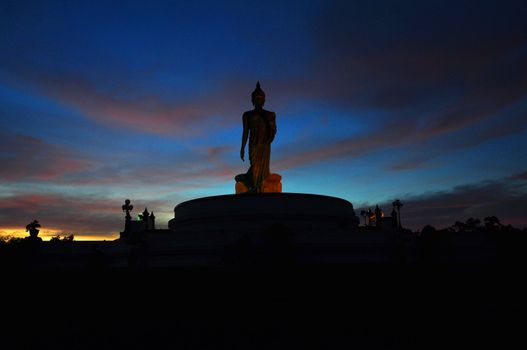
(169, 193, 358, 232)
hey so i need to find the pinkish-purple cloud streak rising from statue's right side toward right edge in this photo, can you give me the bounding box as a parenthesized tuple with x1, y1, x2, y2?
(273, 101, 527, 170)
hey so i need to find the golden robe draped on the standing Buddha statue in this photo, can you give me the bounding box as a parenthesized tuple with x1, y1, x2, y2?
(243, 109, 276, 192)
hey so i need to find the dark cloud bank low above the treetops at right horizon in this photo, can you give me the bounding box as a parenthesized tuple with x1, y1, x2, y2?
(368, 173, 527, 229)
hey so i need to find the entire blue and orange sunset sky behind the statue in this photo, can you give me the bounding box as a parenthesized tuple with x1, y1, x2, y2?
(0, 0, 527, 239)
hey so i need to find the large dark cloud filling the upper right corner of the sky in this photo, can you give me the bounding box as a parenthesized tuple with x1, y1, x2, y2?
(313, 1, 527, 110)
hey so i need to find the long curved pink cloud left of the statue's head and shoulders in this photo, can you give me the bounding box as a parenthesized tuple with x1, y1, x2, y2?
(27, 74, 250, 137)
